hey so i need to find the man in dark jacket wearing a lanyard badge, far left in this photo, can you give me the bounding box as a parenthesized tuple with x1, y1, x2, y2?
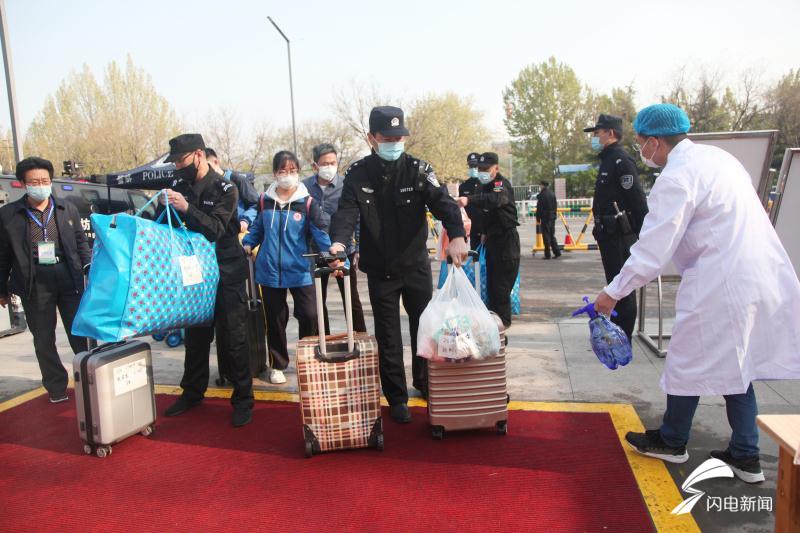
(0, 157, 92, 403)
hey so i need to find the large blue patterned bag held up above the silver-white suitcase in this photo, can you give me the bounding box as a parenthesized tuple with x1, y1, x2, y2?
(72, 191, 219, 342)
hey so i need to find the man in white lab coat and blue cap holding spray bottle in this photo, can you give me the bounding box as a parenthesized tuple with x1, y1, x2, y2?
(595, 104, 800, 483)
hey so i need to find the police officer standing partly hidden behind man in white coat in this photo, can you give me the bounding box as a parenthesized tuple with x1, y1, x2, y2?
(583, 114, 647, 339)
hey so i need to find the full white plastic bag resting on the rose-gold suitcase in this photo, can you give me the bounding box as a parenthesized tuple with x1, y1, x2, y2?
(417, 265, 500, 362)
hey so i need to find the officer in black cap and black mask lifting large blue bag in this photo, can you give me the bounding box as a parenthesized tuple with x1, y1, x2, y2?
(159, 133, 253, 427)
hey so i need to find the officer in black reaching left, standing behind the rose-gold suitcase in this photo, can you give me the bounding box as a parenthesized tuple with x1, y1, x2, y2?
(458, 152, 520, 327)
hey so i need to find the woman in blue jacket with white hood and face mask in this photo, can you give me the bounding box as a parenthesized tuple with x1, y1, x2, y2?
(242, 151, 331, 383)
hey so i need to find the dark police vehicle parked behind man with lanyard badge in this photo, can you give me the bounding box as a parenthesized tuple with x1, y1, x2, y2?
(0, 175, 156, 246)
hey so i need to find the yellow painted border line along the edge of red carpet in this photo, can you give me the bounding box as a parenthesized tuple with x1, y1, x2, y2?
(0, 385, 700, 533)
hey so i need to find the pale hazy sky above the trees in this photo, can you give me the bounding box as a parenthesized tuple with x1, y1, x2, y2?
(0, 0, 800, 140)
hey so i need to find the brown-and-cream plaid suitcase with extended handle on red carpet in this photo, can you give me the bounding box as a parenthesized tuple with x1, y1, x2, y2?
(297, 256, 383, 457)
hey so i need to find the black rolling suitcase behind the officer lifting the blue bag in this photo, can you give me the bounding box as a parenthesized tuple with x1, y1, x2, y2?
(215, 258, 267, 386)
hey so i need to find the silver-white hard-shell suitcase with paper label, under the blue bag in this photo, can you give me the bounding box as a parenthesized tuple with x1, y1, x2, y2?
(72, 340, 156, 457)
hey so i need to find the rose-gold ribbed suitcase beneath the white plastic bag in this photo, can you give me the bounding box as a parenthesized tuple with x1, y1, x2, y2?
(428, 260, 509, 439)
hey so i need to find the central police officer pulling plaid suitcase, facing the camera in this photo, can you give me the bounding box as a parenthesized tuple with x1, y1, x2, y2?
(329, 106, 467, 423)
